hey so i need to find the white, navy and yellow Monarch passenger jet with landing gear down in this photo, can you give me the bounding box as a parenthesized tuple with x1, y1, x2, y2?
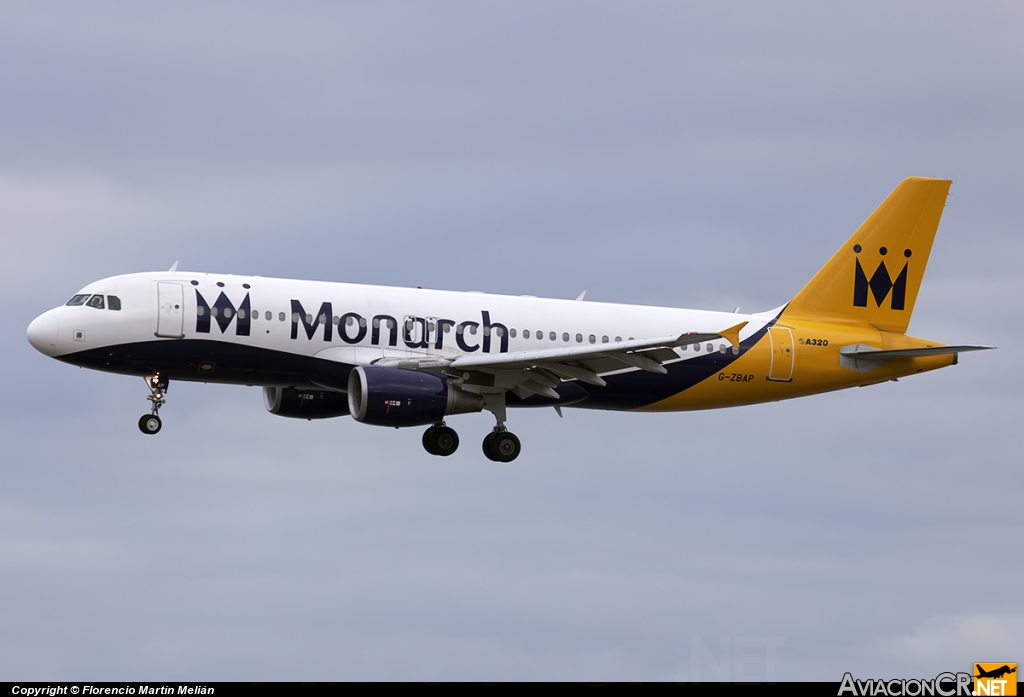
(28, 177, 991, 463)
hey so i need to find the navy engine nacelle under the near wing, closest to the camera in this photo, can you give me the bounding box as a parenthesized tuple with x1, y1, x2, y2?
(348, 365, 483, 426)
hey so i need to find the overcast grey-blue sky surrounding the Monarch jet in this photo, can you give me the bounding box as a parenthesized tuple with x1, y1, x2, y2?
(0, 0, 1024, 681)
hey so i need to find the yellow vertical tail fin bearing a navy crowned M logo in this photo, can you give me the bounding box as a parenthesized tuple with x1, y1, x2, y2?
(785, 177, 950, 334)
